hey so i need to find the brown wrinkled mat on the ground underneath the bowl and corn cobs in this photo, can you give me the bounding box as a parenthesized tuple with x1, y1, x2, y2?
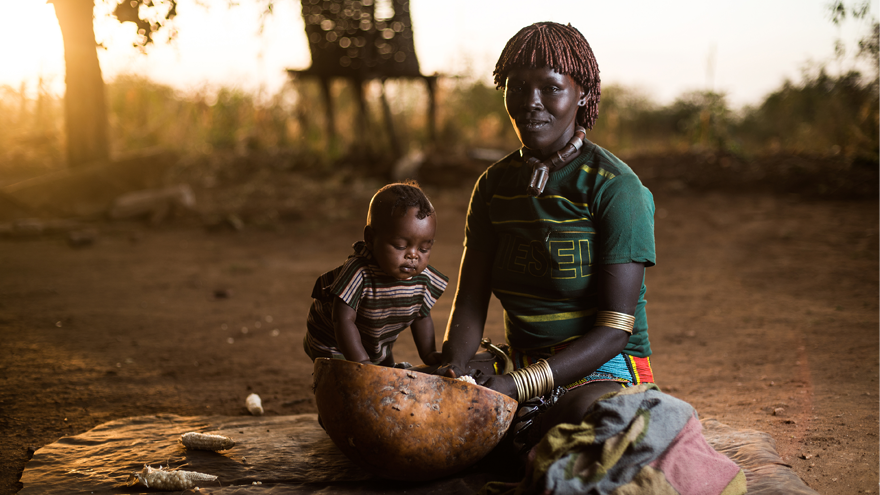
(19, 414, 816, 495)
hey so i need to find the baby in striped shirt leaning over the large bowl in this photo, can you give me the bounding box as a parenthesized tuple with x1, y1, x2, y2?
(303, 181, 449, 366)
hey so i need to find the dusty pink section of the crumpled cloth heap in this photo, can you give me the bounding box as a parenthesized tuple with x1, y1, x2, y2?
(649, 415, 740, 495)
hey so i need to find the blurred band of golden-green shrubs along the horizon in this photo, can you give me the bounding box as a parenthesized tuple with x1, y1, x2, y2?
(0, 54, 880, 182)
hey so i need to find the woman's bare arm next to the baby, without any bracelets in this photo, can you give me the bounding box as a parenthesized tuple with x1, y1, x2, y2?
(437, 247, 495, 377)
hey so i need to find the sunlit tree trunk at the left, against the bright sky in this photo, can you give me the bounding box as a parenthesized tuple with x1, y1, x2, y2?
(49, 0, 109, 167)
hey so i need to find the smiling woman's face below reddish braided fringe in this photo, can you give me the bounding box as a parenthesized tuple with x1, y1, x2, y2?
(504, 67, 586, 156)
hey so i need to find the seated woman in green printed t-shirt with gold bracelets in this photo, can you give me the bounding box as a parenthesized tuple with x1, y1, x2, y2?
(438, 22, 655, 446)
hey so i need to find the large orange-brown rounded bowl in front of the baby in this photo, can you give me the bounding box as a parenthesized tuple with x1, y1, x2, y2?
(315, 358, 517, 481)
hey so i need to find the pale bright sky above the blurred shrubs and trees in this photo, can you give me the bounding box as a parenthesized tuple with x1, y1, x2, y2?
(0, 0, 880, 107)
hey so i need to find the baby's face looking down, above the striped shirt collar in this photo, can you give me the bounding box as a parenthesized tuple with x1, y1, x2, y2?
(365, 207, 437, 280)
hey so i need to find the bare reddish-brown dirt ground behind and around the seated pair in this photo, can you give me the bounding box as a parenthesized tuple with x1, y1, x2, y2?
(0, 153, 880, 494)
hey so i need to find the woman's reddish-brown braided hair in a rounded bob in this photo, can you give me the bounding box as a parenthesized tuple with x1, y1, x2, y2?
(492, 22, 601, 129)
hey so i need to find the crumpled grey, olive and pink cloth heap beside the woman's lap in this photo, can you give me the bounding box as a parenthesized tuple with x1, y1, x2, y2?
(483, 383, 746, 495)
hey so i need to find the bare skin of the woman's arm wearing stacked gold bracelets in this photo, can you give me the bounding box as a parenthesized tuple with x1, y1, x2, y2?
(483, 263, 645, 398)
